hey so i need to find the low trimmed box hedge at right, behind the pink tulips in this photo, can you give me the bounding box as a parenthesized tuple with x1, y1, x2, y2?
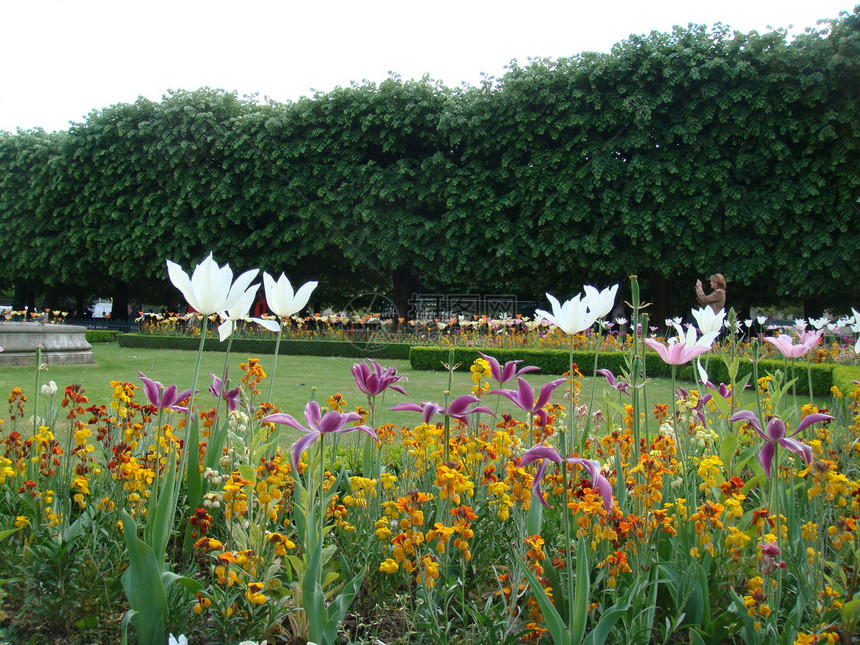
(409, 346, 848, 396)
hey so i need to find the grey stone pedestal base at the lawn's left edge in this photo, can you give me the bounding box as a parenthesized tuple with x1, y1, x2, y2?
(0, 322, 95, 365)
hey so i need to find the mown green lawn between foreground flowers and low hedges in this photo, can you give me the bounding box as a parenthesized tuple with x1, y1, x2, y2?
(0, 343, 827, 441)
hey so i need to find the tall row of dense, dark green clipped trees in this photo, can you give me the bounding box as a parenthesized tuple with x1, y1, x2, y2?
(0, 7, 860, 316)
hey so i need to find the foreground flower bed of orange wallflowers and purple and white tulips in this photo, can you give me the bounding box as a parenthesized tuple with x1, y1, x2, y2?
(0, 259, 860, 645)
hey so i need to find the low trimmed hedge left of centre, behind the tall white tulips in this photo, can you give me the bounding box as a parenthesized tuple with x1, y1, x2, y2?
(117, 334, 409, 360)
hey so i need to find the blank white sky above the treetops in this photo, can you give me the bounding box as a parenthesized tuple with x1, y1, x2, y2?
(0, 0, 858, 132)
